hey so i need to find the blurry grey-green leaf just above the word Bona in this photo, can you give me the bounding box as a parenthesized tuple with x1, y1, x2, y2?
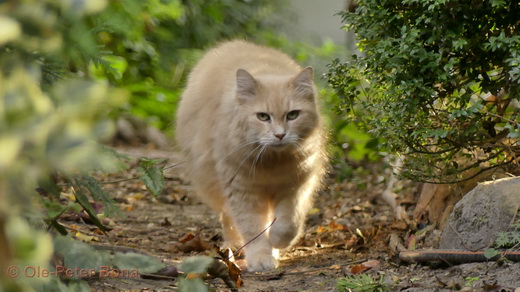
(114, 252, 166, 274)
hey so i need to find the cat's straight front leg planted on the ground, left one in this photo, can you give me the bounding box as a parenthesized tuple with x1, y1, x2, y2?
(226, 192, 278, 271)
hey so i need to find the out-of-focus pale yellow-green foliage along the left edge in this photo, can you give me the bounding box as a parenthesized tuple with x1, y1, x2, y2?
(0, 0, 126, 291)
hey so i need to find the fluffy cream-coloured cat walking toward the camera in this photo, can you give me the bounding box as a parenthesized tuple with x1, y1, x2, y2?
(177, 41, 326, 271)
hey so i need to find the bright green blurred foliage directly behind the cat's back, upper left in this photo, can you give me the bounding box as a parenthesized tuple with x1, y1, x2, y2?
(89, 0, 283, 131)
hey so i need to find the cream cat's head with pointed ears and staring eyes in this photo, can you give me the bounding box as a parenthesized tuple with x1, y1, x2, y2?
(236, 67, 320, 149)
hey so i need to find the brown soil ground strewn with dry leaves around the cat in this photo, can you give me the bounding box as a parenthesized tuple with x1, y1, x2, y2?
(66, 147, 520, 291)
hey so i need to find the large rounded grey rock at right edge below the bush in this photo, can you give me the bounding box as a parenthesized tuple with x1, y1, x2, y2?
(439, 177, 520, 251)
